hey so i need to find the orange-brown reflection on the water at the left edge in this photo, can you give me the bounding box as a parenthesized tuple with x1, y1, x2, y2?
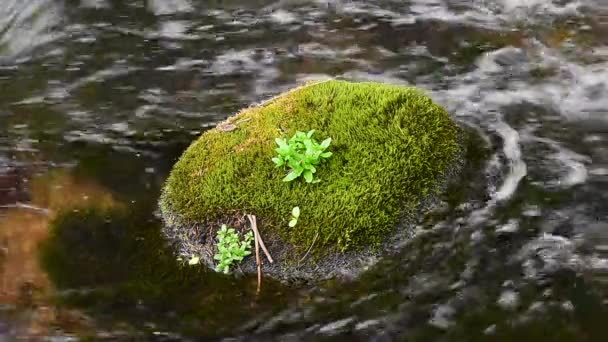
(0, 171, 117, 337)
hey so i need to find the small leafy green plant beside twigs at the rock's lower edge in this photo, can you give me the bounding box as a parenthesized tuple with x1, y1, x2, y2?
(213, 224, 253, 274)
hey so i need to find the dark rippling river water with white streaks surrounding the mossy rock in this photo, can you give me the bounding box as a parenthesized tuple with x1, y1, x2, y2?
(0, 0, 608, 341)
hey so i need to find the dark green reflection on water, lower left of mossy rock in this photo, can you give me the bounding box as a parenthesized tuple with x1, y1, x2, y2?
(40, 207, 290, 336)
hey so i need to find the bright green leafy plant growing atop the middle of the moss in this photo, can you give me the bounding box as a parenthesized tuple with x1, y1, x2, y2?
(272, 129, 332, 183)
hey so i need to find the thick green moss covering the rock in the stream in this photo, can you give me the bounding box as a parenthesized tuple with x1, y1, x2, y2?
(161, 81, 460, 252)
